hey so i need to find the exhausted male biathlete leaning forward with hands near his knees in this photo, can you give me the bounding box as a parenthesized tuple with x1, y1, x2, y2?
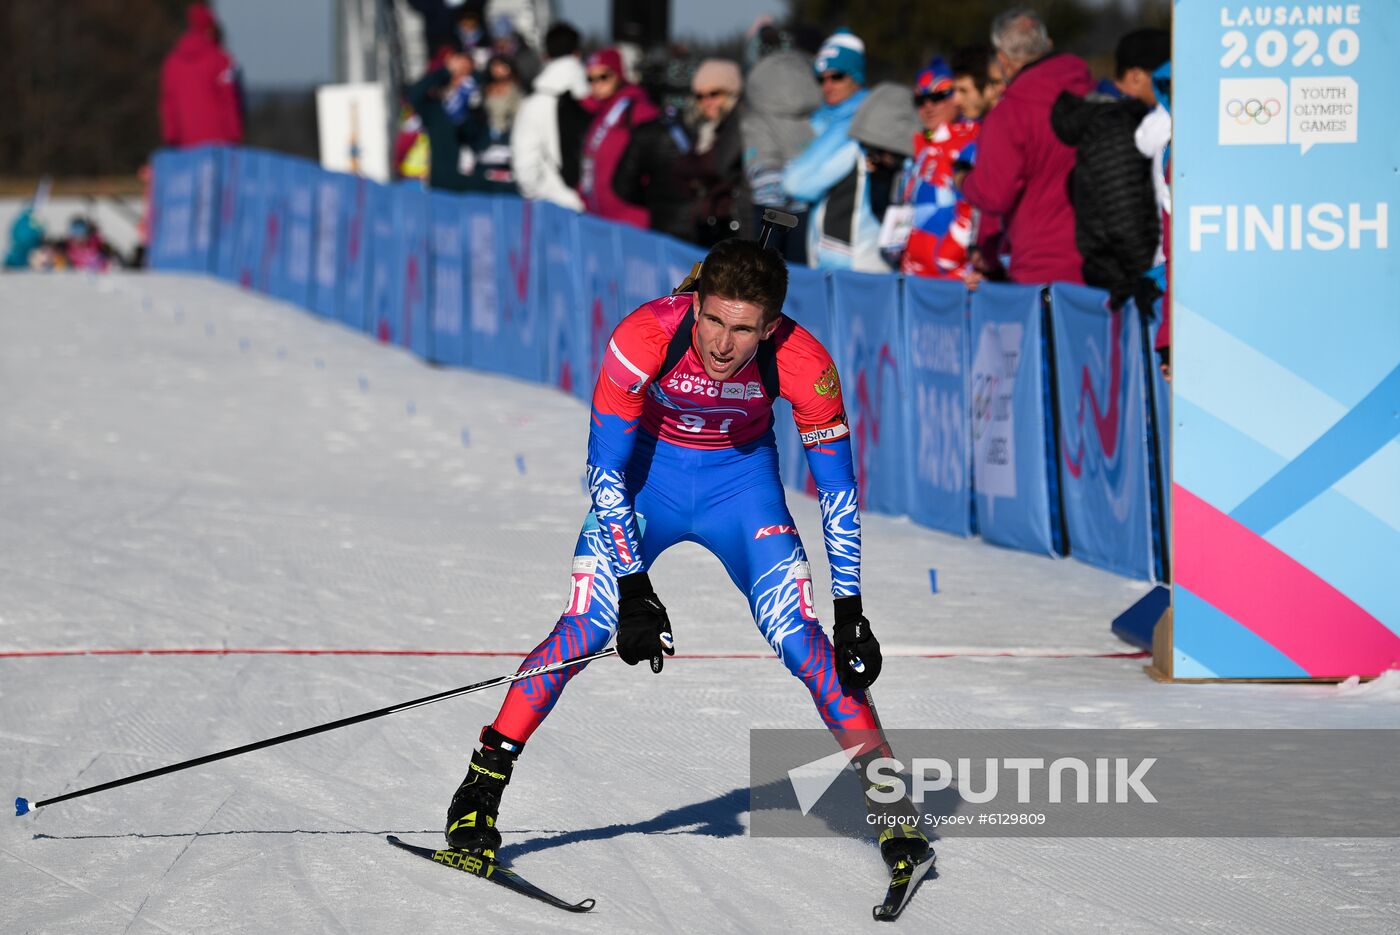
(447, 239, 928, 866)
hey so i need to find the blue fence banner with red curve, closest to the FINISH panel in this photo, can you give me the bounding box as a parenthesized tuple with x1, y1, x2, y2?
(1050, 283, 1152, 578)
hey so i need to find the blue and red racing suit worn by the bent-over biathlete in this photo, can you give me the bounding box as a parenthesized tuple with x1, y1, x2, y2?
(491, 294, 876, 743)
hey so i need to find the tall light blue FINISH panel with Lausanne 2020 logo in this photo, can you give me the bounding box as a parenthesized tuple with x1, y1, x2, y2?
(1170, 0, 1400, 677)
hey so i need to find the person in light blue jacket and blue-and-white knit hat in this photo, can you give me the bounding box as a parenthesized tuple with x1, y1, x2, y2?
(783, 29, 879, 269)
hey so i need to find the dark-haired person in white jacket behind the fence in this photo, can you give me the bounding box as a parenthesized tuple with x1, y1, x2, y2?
(511, 22, 588, 211)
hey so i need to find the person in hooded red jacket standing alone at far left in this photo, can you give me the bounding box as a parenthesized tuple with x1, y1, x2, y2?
(161, 3, 244, 147)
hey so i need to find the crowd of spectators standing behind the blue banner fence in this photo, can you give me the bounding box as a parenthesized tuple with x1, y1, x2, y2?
(395, 0, 1170, 323)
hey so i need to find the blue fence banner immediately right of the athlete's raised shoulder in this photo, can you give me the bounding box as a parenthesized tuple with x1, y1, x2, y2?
(827, 270, 909, 514)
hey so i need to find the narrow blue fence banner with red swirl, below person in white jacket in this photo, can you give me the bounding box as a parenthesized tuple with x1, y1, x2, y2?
(491, 196, 545, 381)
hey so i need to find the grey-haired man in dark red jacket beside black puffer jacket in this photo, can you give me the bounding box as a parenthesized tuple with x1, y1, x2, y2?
(960, 10, 1093, 283)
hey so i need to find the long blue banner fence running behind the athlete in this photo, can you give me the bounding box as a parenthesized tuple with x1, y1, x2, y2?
(151, 147, 1168, 579)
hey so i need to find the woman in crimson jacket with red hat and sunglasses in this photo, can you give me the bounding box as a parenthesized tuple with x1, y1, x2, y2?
(578, 49, 661, 230)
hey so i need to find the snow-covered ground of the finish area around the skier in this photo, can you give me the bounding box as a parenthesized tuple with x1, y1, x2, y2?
(0, 276, 1400, 934)
